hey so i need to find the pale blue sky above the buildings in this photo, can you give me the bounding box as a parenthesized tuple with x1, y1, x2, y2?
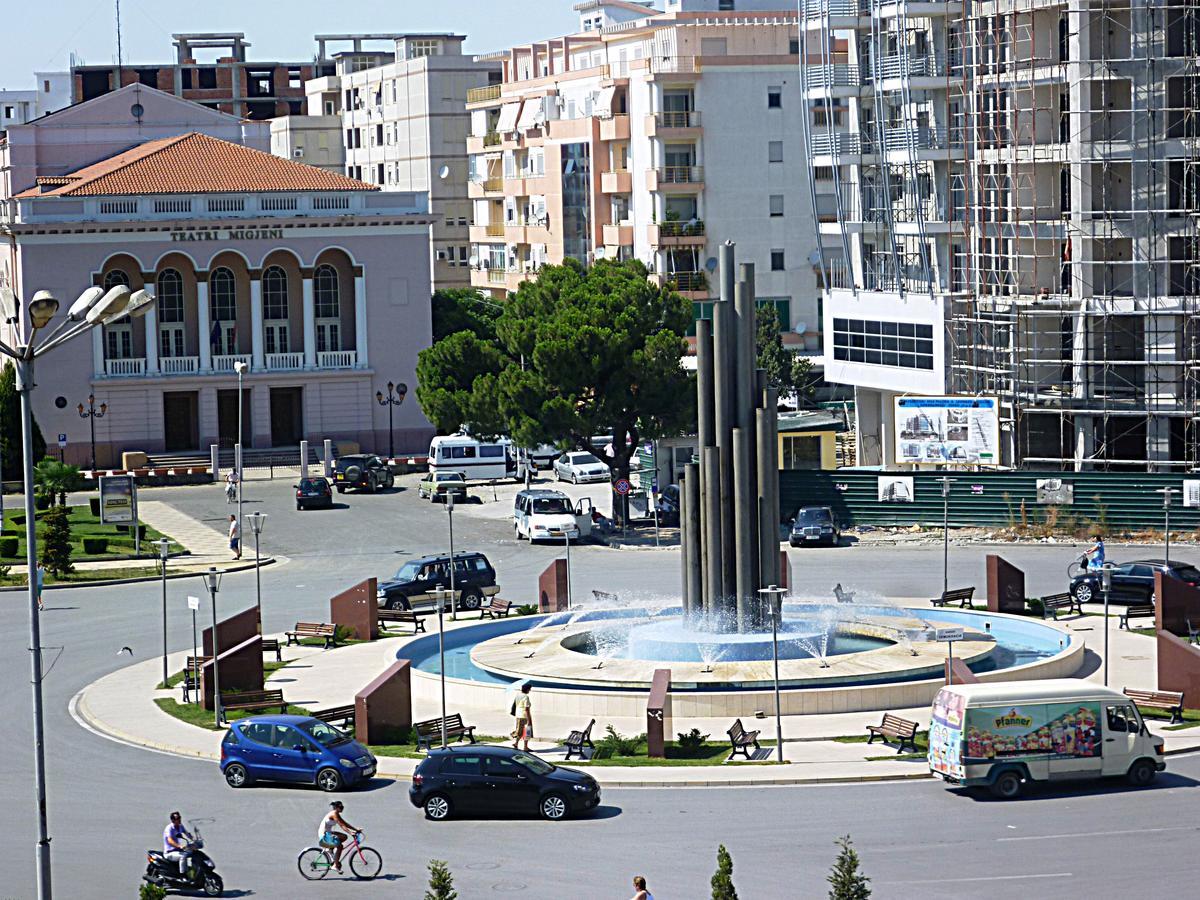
(0, 0, 578, 90)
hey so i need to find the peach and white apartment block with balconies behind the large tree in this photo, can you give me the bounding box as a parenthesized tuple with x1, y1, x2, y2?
(467, 0, 835, 352)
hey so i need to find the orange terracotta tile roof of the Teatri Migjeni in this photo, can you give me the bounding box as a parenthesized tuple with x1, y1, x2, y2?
(19, 132, 379, 197)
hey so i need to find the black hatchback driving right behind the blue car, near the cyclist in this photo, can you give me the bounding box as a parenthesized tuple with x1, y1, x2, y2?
(408, 744, 600, 822)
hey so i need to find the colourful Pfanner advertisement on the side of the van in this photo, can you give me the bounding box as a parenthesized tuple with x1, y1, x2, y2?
(966, 703, 1102, 763)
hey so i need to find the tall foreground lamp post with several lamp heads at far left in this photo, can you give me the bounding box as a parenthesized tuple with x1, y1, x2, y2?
(0, 278, 154, 900)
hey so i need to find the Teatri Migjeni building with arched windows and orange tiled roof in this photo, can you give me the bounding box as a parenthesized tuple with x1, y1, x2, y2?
(0, 130, 432, 466)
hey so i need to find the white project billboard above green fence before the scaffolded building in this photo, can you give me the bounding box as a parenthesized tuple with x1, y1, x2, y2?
(894, 397, 1000, 466)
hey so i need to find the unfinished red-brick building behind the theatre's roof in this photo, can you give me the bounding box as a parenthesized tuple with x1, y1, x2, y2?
(71, 32, 334, 120)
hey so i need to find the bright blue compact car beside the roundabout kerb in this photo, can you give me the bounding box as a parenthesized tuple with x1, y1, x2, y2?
(221, 715, 376, 791)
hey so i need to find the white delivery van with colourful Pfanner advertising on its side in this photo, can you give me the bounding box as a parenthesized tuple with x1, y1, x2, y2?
(929, 678, 1166, 799)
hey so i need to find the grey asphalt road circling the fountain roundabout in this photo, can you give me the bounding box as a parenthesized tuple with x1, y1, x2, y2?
(0, 481, 1200, 900)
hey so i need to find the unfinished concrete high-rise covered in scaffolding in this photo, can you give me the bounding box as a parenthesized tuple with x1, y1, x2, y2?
(800, 0, 1200, 472)
